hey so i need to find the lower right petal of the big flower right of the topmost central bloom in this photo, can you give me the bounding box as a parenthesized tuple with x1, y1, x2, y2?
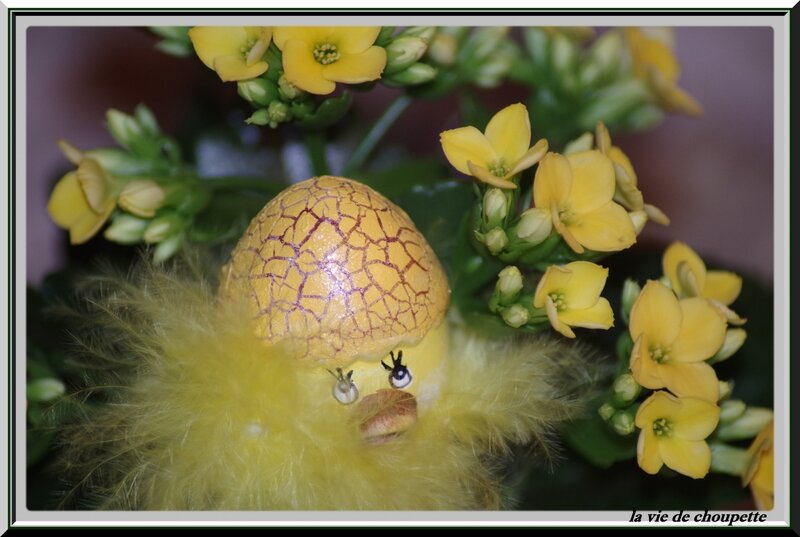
(567, 201, 636, 252)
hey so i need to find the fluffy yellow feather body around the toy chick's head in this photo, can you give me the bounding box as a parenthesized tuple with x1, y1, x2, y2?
(59, 253, 591, 510)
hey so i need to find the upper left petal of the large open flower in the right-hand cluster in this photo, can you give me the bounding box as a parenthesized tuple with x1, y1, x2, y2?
(630, 280, 683, 346)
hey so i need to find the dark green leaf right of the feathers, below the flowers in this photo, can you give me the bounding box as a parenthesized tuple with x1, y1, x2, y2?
(564, 406, 636, 468)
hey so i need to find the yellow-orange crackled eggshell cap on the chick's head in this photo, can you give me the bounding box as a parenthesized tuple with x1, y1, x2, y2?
(219, 176, 450, 367)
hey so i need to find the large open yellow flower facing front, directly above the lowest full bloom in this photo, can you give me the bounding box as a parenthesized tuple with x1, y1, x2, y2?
(630, 280, 725, 402)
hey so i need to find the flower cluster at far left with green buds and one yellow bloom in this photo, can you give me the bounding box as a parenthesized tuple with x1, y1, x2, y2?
(47, 105, 209, 261)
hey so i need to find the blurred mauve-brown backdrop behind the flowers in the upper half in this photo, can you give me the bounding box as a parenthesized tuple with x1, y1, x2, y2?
(26, 27, 776, 286)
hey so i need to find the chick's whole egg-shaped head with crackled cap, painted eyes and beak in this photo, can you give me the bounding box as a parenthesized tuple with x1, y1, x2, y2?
(218, 176, 449, 442)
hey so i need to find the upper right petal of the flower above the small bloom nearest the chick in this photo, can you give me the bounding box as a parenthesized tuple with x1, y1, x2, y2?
(566, 151, 616, 213)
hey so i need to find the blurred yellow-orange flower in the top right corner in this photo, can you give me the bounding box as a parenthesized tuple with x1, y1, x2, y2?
(625, 28, 703, 116)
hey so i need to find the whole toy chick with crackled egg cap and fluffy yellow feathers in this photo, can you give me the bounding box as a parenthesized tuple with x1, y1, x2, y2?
(63, 176, 591, 510)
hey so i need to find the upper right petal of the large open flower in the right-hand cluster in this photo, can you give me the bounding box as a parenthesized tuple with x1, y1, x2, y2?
(671, 297, 725, 362)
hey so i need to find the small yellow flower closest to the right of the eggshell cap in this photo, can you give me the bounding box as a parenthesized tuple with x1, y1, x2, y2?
(533, 261, 614, 338)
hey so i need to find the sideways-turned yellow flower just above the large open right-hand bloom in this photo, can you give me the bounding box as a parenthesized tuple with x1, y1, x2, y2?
(662, 241, 746, 325)
